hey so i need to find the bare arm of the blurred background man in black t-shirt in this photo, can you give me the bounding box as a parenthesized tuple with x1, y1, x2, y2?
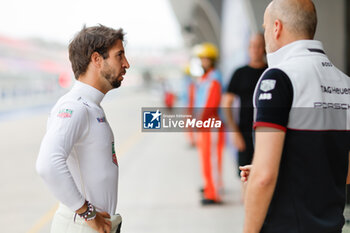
(222, 92, 245, 151)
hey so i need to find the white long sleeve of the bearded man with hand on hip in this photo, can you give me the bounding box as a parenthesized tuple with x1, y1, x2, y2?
(36, 102, 89, 211)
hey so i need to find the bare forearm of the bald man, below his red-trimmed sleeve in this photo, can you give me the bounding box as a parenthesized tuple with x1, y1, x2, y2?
(244, 127, 285, 233)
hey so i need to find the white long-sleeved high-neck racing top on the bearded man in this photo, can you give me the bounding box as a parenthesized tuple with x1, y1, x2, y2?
(36, 81, 118, 215)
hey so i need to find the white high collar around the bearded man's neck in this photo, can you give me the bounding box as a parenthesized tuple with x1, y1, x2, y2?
(72, 80, 105, 105)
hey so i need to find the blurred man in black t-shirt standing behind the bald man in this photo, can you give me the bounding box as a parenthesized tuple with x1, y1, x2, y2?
(223, 34, 267, 174)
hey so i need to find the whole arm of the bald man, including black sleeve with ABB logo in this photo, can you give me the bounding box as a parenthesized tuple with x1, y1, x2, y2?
(244, 69, 293, 233)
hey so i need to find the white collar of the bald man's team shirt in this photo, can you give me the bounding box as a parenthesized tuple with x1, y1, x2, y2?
(267, 40, 324, 67)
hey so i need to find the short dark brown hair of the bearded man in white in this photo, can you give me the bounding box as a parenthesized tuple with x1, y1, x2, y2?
(68, 24, 124, 79)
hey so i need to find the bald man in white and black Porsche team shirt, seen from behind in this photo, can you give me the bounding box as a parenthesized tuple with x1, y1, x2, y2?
(242, 0, 350, 233)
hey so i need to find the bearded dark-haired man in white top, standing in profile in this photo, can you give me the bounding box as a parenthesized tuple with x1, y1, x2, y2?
(36, 25, 129, 233)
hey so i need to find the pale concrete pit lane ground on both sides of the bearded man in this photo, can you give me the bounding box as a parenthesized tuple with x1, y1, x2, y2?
(0, 89, 243, 233)
